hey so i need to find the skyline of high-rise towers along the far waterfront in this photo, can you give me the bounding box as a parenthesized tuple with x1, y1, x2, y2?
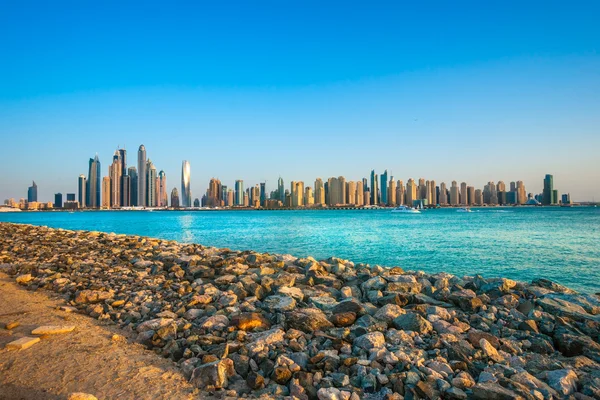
(5, 159, 571, 209)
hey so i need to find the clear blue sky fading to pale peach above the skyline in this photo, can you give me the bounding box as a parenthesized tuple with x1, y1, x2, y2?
(0, 0, 600, 202)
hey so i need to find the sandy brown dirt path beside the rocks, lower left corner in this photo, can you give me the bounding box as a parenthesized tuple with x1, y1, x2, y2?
(0, 273, 200, 400)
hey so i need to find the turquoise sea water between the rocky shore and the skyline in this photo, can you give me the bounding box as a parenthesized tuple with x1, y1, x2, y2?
(0, 207, 600, 293)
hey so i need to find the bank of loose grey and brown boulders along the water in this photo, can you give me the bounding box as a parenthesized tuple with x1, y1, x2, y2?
(0, 223, 600, 400)
